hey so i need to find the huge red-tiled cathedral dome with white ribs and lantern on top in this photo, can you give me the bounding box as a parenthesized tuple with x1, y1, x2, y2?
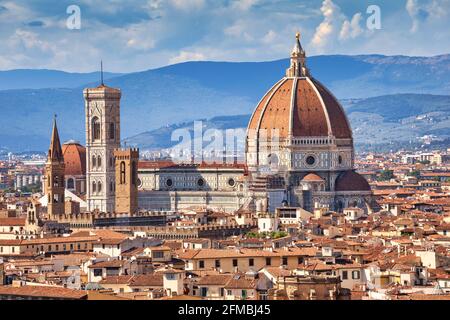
(248, 35, 352, 139)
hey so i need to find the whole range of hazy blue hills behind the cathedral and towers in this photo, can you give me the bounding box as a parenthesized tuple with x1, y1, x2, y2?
(0, 55, 450, 151)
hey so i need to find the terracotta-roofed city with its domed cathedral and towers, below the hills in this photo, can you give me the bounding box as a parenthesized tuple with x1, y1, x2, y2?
(0, 33, 450, 301)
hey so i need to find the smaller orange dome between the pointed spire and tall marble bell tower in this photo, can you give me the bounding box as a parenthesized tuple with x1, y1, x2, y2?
(62, 140, 86, 176)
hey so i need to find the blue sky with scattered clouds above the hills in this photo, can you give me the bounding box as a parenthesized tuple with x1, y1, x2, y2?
(0, 0, 450, 72)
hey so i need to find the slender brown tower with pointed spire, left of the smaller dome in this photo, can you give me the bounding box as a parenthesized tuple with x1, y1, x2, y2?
(45, 117, 65, 219)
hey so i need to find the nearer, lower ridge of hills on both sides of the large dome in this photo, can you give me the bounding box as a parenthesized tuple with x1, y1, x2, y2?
(125, 94, 450, 151)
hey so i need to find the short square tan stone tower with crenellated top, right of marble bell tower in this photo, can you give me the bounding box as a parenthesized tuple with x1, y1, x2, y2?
(114, 149, 139, 214)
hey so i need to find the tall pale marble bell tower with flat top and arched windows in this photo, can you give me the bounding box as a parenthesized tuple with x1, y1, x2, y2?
(84, 76, 121, 212)
